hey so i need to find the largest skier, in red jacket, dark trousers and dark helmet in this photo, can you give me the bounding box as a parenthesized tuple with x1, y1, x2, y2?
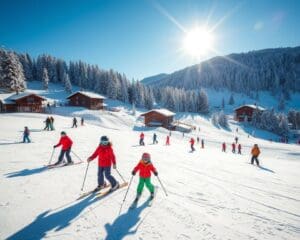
(87, 136, 119, 191)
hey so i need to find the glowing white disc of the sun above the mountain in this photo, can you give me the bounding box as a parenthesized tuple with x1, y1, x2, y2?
(183, 28, 213, 57)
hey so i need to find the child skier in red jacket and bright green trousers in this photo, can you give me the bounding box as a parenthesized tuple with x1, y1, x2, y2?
(132, 153, 158, 204)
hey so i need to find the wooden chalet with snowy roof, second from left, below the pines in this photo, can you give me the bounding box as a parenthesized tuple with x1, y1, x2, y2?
(67, 91, 106, 110)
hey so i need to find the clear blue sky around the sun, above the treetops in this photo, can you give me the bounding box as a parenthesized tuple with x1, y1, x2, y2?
(0, 0, 300, 79)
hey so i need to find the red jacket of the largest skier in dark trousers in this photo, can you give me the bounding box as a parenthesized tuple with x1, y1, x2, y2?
(89, 145, 116, 167)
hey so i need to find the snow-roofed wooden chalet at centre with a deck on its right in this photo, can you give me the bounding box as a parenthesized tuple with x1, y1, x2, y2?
(141, 109, 175, 129)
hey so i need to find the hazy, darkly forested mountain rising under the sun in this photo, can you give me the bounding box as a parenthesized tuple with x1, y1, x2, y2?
(143, 47, 300, 96)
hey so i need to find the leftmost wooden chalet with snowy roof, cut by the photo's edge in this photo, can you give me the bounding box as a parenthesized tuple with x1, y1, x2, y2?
(0, 92, 46, 113)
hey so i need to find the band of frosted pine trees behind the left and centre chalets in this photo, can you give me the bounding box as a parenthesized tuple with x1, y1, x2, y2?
(0, 48, 209, 113)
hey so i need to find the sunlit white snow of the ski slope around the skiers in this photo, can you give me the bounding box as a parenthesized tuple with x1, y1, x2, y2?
(0, 108, 300, 240)
